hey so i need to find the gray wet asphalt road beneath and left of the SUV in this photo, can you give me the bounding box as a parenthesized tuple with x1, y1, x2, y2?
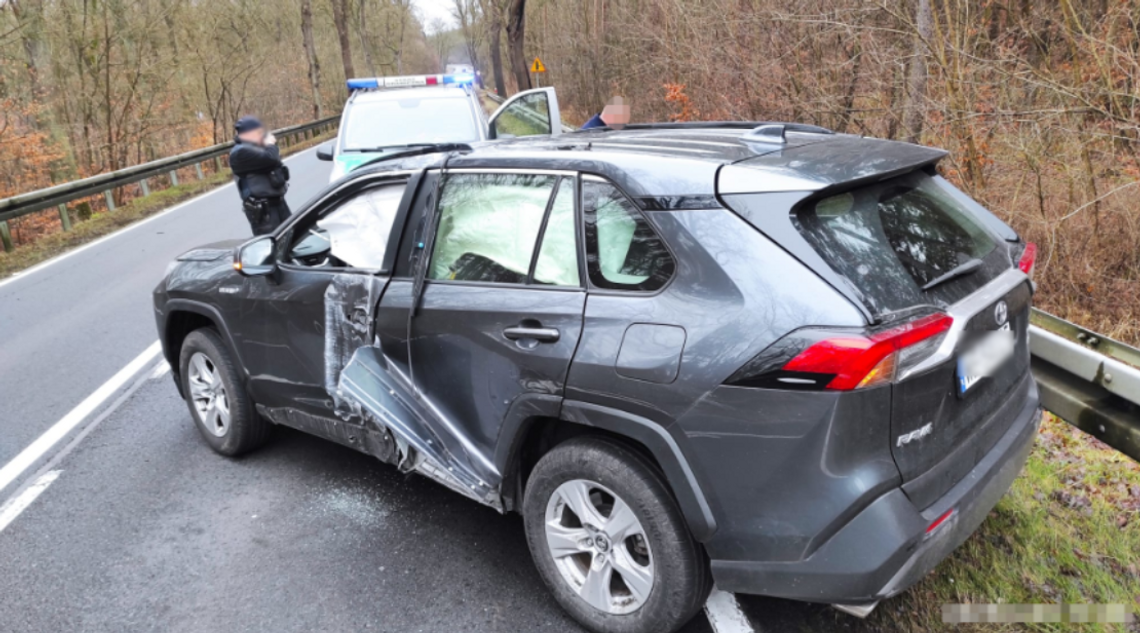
(0, 151, 848, 633)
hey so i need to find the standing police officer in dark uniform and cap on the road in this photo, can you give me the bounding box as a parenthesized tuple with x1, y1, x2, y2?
(229, 116, 291, 235)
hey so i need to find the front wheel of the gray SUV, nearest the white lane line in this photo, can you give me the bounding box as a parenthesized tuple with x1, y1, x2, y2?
(179, 328, 272, 457)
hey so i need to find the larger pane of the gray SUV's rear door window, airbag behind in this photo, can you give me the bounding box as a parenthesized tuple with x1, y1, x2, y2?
(428, 173, 557, 284)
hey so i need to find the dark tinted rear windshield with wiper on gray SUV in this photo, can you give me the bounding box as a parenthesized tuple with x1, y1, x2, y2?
(793, 172, 1004, 311)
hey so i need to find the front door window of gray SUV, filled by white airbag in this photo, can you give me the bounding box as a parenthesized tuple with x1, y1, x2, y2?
(288, 182, 405, 270)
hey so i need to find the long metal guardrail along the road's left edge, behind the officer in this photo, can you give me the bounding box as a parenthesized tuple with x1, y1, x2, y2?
(0, 115, 340, 252)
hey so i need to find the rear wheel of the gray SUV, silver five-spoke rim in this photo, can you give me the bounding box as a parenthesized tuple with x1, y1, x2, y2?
(523, 437, 713, 633)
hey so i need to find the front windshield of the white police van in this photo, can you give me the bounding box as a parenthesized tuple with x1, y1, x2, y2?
(341, 97, 479, 152)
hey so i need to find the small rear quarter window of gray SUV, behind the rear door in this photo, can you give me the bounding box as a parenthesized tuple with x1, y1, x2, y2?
(581, 179, 676, 291)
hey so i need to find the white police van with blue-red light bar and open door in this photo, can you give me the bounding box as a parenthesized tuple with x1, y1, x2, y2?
(317, 74, 563, 182)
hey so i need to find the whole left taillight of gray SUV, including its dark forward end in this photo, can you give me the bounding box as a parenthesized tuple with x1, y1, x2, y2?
(728, 313, 954, 391)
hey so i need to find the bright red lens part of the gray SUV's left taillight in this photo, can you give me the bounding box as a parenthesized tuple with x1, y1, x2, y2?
(783, 314, 954, 391)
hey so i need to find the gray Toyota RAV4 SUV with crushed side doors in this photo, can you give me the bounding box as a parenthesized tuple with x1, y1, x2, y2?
(154, 123, 1040, 633)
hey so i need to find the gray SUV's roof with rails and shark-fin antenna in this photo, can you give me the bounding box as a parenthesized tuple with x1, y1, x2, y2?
(351, 123, 946, 200)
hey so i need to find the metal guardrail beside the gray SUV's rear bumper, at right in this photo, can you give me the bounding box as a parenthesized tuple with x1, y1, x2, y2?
(1029, 309, 1140, 461)
